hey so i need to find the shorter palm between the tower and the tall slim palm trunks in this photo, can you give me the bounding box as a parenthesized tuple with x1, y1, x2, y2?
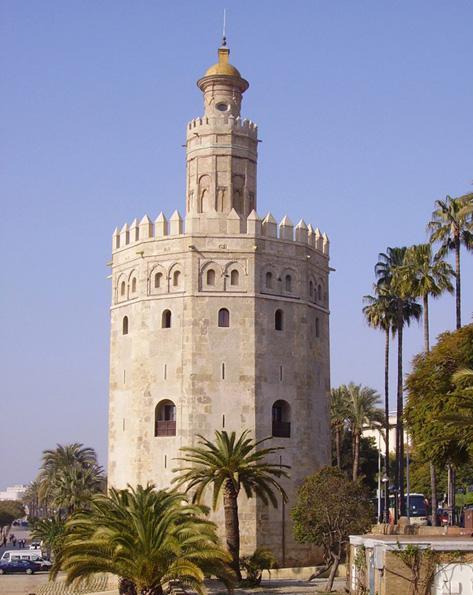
(342, 382, 384, 481)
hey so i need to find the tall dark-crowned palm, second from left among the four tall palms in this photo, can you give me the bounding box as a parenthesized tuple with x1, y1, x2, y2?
(375, 247, 422, 519)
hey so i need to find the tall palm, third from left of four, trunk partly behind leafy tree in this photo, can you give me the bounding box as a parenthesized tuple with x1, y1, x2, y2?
(405, 244, 455, 525)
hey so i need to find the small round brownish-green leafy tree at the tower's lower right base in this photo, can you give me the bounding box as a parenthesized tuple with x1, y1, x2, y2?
(292, 467, 372, 591)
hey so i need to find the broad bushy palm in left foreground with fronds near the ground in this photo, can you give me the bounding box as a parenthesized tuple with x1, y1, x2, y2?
(52, 485, 232, 595)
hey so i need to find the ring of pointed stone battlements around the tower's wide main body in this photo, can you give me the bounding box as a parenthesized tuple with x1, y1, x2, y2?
(112, 209, 330, 257)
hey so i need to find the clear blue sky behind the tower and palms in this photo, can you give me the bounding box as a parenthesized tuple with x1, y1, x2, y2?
(0, 0, 473, 487)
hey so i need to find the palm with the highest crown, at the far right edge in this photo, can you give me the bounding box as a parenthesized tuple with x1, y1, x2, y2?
(427, 194, 473, 329)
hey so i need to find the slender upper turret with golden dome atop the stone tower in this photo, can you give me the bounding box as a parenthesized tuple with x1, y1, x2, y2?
(186, 39, 258, 228)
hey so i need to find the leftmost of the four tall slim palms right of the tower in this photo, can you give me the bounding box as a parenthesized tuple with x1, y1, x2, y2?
(363, 285, 396, 500)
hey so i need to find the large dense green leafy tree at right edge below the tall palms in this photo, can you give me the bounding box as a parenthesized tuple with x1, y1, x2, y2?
(405, 324, 473, 524)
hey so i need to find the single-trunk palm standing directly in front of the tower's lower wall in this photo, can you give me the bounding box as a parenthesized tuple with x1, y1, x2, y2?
(173, 430, 289, 580)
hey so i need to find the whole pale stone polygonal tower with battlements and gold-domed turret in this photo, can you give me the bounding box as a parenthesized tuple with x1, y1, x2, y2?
(108, 44, 330, 566)
